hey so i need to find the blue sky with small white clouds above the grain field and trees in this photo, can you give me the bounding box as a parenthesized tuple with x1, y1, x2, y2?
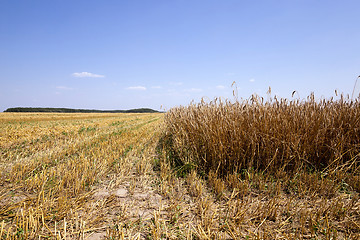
(0, 0, 360, 111)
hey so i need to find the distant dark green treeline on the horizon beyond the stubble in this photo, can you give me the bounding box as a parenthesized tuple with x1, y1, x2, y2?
(4, 107, 159, 113)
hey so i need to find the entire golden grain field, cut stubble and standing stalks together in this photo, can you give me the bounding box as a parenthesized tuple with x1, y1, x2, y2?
(0, 96, 360, 239)
